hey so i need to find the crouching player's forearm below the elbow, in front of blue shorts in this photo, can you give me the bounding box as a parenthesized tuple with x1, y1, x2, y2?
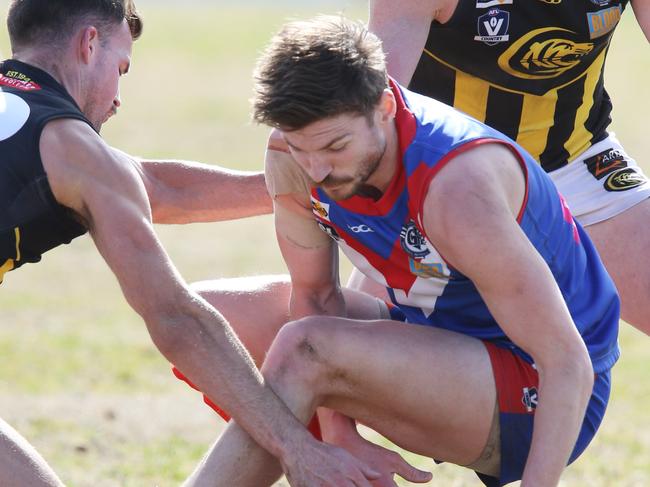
(521, 357, 593, 487)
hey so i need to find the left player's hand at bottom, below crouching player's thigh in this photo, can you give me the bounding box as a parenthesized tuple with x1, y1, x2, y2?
(282, 438, 381, 487)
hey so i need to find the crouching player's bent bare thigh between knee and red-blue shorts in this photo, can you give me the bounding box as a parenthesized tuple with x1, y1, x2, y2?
(269, 317, 496, 465)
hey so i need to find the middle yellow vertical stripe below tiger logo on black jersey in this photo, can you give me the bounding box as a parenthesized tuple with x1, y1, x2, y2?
(517, 91, 557, 161)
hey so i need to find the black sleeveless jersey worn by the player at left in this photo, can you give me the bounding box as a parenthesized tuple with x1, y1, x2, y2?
(0, 60, 90, 282)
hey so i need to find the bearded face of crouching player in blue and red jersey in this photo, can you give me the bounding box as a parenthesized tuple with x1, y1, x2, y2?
(283, 109, 386, 200)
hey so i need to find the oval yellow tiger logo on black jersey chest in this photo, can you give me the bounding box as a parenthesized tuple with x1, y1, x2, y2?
(498, 27, 594, 79)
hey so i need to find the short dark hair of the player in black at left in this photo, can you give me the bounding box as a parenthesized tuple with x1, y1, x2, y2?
(7, 0, 142, 51)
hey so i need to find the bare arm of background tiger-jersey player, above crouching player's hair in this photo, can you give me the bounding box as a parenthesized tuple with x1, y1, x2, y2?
(368, 0, 458, 86)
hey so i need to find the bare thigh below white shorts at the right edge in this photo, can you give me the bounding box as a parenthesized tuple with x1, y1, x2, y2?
(586, 199, 650, 334)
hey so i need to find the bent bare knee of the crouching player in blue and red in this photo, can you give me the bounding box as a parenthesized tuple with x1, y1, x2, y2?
(262, 317, 324, 386)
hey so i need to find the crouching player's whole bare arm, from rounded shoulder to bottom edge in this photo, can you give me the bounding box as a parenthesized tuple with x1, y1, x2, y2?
(423, 145, 593, 486)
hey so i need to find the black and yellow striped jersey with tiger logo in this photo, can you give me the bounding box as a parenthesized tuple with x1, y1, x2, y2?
(410, 0, 628, 171)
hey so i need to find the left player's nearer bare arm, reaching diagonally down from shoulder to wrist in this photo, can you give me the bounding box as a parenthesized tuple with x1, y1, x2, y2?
(41, 120, 332, 476)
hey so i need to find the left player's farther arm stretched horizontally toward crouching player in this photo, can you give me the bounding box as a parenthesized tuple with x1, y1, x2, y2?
(114, 149, 273, 223)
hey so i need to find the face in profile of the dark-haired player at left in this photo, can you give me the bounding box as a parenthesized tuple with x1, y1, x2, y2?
(82, 21, 133, 131)
